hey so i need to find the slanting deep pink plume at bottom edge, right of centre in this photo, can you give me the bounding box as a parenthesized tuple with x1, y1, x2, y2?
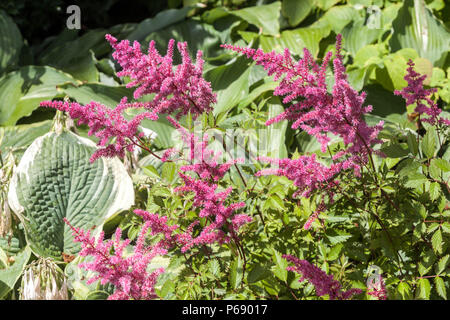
(283, 255, 363, 300)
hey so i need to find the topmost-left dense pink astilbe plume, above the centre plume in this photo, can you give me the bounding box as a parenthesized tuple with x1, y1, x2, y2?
(106, 34, 216, 119)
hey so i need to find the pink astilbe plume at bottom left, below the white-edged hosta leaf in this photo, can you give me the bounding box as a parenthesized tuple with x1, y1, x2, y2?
(64, 218, 167, 300)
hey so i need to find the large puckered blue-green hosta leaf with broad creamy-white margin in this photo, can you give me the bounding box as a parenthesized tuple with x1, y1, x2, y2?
(8, 131, 134, 258)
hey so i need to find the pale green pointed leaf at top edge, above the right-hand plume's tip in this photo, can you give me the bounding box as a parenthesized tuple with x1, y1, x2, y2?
(231, 1, 281, 35)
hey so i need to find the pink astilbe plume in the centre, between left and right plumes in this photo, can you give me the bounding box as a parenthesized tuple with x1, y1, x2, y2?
(163, 117, 251, 252)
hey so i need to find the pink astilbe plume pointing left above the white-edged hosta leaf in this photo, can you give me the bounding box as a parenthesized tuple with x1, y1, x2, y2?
(40, 97, 152, 162)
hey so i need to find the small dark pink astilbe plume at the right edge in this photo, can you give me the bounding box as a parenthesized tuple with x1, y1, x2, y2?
(394, 59, 450, 126)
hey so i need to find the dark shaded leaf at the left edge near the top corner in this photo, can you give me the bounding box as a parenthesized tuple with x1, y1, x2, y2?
(0, 10, 23, 75)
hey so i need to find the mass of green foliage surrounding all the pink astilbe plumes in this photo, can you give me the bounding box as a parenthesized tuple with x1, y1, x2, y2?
(0, 0, 450, 299)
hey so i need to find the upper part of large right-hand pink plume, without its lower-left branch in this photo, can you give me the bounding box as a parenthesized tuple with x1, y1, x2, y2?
(223, 35, 383, 172)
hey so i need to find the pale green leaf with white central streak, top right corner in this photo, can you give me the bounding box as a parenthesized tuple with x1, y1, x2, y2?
(389, 0, 450, 67)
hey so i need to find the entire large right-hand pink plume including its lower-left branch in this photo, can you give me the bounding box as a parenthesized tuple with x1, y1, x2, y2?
(223, 35, 383, 229)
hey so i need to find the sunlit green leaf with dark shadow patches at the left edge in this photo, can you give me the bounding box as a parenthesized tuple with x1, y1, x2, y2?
(0, 66, 75, 126)
